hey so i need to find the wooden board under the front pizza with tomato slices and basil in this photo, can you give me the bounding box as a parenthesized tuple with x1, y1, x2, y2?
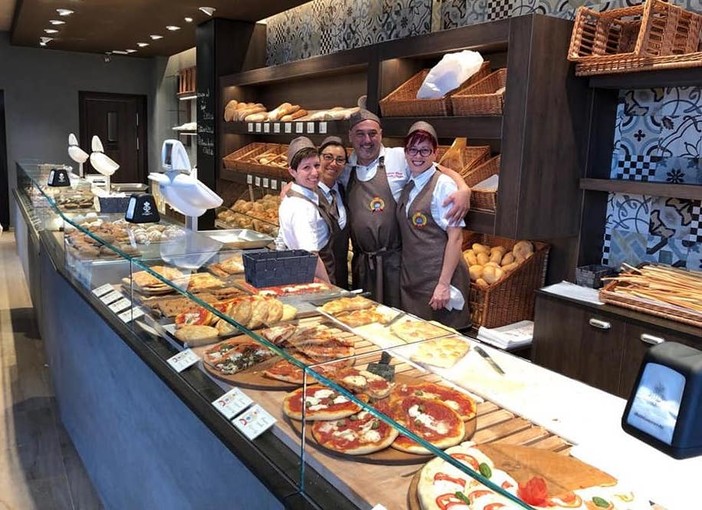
(407, 444, 617, 510)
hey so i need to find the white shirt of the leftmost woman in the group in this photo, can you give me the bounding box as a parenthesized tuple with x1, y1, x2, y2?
(278, 183, 329, 252)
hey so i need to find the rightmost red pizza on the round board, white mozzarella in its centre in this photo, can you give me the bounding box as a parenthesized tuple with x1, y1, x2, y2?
(387, 396, 466, 454)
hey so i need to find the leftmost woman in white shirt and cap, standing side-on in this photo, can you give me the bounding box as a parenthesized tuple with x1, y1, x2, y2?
(278, 136, 329, 282)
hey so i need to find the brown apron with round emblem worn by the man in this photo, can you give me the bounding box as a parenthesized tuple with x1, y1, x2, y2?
(347, 156, 402, 307)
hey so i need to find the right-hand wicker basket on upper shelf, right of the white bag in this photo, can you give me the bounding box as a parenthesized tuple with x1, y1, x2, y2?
(451, 68, 507, 115)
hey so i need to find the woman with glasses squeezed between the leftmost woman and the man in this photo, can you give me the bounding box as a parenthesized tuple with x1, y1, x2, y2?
(317, 136, 349, 289)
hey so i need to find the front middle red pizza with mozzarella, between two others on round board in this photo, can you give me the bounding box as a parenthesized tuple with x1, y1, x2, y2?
(312, 411, 397, 455)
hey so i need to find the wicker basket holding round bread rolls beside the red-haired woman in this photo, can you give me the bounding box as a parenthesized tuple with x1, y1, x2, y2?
(463, 232, 550, 328)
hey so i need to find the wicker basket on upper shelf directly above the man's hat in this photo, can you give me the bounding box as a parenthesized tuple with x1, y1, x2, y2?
(380, 62, 490, 117)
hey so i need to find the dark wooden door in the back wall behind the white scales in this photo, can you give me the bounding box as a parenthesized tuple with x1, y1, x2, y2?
(79, 92, 148, 182)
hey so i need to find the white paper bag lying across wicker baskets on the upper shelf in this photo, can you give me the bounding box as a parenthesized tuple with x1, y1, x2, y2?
(417, 50, 483, 99)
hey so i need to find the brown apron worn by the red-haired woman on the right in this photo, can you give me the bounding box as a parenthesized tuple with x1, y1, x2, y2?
(397, 172, 471, 329)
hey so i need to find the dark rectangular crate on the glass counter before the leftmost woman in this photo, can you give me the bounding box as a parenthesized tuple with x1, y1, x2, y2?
(243, 250, 317, 287)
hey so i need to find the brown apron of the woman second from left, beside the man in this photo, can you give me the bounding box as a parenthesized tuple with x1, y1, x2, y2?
(316, 185, 349, 289)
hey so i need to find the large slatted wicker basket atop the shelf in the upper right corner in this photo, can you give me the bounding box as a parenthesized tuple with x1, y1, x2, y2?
(568, 0, 702, 62)
